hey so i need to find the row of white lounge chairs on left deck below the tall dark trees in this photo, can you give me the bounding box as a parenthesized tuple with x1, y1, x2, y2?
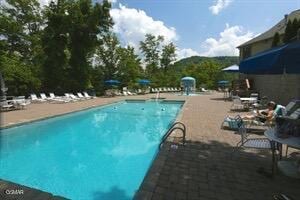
(30, 92, 95, 103)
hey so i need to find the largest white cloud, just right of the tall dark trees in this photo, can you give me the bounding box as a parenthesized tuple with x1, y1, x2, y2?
(110, 4, 178, 49)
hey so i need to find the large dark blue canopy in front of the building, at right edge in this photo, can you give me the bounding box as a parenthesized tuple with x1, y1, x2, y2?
(239, 41, 300, 74)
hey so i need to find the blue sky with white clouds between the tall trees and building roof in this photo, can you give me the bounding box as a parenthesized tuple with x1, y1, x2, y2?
(40, 0, 300, 59)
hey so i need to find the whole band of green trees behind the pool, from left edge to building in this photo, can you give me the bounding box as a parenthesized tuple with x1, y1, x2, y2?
(0, 0, 239, 95)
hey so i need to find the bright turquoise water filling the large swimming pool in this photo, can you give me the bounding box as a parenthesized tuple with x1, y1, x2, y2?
(0, 101, 182, 200)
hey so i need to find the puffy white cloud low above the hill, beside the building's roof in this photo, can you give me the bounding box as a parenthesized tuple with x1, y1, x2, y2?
(201, 24, 255, 56)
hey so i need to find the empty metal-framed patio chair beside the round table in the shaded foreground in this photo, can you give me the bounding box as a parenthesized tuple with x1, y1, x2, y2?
(232, 123, 275, 175)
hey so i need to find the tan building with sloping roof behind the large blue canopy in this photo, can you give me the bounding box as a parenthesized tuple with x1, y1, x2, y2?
(237, 10, 300, 105)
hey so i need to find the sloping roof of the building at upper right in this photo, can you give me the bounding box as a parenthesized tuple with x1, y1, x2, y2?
(237, 9, 300, 48)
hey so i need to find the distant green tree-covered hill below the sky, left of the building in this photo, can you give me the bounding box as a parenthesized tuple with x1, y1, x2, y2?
(174, 56, 239, 68)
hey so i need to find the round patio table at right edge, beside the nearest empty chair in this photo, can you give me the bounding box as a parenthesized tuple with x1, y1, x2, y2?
(264, 128, 300, 178)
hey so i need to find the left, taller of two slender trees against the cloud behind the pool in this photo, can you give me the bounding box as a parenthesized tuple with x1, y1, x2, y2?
(140, 34, 164, 78)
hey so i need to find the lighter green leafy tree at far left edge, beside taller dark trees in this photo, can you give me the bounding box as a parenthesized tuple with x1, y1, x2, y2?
(0, 0, 43, 95)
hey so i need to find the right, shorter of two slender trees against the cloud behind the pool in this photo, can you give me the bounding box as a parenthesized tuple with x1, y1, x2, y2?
(160, 42, 176, 73)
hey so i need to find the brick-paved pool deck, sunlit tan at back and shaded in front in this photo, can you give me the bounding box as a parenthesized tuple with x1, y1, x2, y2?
(0, 93, 300, 200)
